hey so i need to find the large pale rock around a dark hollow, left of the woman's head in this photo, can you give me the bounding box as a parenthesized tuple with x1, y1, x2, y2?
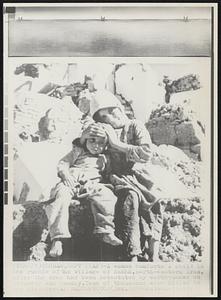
(14, 92, 82, 139)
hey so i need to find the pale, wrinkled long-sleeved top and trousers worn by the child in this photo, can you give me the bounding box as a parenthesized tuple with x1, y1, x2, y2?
(46, 143, 117, 240)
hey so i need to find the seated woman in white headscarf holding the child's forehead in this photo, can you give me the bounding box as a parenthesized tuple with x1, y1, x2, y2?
(76, 91, 163, 261)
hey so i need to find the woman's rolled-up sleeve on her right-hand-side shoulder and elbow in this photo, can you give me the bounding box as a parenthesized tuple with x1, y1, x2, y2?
(126, 120, 152, 163)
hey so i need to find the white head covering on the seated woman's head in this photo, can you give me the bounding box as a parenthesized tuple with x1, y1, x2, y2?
(90, 90, 124, 117)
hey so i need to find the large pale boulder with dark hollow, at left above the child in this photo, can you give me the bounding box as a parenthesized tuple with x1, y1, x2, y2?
(14, 92, 82, 142)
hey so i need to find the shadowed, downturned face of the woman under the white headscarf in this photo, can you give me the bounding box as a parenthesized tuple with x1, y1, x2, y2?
(98, 107, 126, 129)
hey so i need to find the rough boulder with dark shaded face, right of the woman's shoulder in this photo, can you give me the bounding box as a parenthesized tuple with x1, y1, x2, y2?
(146, 104, 204, 159)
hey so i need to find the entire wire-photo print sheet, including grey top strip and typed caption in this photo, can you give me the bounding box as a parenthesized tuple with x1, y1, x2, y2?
(4, 3, 216, 297)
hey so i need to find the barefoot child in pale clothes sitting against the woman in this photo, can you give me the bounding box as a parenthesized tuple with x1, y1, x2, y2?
(46, 125, 122, 257)
